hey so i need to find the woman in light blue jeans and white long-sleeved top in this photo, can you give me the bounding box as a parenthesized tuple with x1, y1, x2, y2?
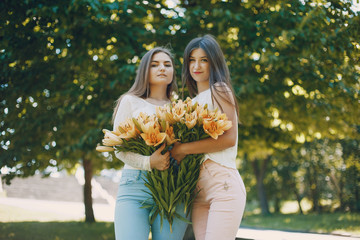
(113, 47, 187, 240)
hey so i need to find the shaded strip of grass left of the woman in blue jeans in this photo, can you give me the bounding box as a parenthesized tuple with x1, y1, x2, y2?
(0, 222, 114, 240)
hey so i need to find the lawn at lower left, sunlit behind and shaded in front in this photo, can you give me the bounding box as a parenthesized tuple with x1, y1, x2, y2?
(0, 204, 115, 240)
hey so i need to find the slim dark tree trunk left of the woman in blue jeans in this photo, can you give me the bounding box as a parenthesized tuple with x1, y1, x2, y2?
(83, 158, 95, 223)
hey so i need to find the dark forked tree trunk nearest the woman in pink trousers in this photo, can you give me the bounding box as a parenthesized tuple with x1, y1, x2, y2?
(251, 156, 270, 215)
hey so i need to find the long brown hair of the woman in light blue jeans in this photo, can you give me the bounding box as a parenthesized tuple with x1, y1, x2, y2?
(112, 47, 177, 122)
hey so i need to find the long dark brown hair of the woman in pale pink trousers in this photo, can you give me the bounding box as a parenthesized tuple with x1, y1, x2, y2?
(182, 34, 239, 116)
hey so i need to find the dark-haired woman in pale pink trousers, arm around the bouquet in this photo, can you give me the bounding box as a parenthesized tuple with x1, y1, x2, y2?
(170, 35, 246, 240)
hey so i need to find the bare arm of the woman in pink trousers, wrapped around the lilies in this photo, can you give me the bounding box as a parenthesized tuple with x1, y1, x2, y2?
(170, 86, 238, 162)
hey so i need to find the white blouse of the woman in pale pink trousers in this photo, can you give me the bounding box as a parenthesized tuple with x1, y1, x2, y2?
(192, 88, 238, 169)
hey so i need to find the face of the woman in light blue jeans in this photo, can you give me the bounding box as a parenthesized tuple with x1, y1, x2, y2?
(149, 52, 174, 85)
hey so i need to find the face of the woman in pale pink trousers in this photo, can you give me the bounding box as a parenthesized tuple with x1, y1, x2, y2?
(189, 48, 210, 83)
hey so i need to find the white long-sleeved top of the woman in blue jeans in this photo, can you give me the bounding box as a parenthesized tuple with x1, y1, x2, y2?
(113, 94, 162, 171)
